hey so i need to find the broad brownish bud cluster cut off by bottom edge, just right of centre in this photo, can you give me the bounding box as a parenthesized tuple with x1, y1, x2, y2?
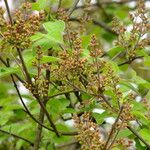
(74, 113, 104, 150)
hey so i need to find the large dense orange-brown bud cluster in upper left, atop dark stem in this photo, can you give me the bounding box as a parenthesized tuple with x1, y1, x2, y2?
(3, 3, 44, 49)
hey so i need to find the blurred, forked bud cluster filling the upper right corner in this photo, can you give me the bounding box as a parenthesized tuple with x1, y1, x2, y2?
(113, 0, 150, 60)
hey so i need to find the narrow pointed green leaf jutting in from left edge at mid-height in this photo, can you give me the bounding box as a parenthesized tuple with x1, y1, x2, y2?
(0, 67, 19, 78)
